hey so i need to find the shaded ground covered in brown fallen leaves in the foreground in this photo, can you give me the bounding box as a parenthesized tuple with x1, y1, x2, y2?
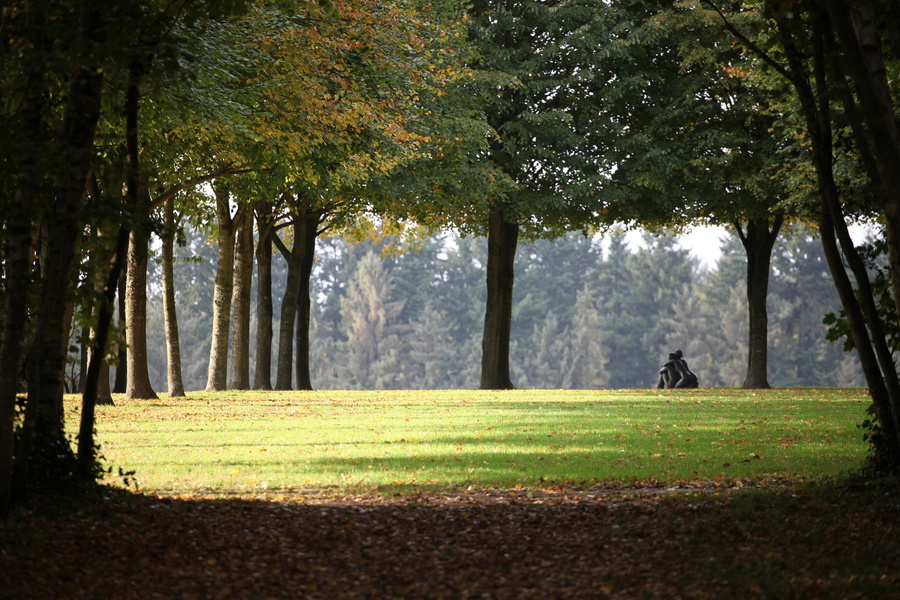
(0, 481, 900, 600)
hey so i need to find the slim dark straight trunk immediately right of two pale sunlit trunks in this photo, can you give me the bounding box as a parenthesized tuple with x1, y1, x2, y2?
(253, 202, 274, 390)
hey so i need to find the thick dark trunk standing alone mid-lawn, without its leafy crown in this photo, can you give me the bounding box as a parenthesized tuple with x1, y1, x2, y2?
(480, 210, 519, 390)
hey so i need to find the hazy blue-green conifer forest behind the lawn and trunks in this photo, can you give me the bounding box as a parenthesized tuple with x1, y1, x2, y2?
(118, 229, 865, 390)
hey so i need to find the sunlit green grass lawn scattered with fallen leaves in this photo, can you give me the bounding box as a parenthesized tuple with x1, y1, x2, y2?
(67, 388, 870, 494)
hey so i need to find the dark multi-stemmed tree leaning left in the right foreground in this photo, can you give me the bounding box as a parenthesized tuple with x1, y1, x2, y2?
(706, 0, 900, 467)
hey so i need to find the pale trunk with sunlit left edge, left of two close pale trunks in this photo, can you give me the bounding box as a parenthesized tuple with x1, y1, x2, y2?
(206, 182, 234, 391)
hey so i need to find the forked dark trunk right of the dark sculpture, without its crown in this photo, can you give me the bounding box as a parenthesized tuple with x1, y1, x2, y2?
(735, 214, 784, 389)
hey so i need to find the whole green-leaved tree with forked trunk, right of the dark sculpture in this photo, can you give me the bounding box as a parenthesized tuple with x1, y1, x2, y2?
(584, 2, 798, 388)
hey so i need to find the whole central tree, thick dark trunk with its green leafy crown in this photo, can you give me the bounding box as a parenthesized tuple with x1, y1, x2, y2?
(470, 0, 602, 389)
